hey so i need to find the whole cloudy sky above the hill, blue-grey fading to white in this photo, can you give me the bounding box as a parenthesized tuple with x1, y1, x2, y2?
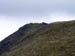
(0, 0, 75, 41)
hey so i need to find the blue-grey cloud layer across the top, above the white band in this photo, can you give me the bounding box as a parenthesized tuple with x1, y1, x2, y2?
(0, 0, 75, 16)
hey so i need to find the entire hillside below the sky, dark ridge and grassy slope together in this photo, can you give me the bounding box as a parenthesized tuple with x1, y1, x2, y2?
(0, 21, 75, 56)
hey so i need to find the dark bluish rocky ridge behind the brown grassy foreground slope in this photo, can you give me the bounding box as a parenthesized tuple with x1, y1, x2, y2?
(0, 23, 45, 54)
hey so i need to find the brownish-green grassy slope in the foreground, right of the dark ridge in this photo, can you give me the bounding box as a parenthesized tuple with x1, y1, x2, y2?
(1, 21, 75, 56)
